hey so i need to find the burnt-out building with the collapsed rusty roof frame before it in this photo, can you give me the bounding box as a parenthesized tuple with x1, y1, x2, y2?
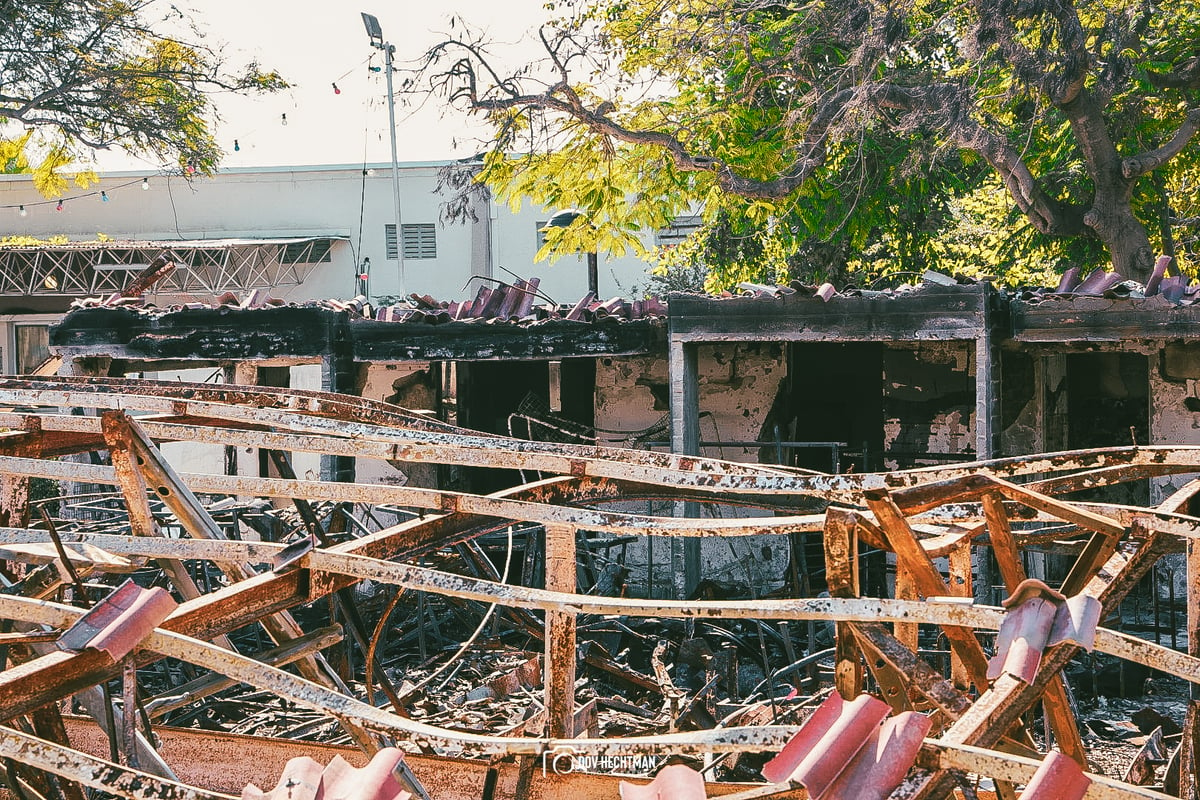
(0, 264, 1200, 800)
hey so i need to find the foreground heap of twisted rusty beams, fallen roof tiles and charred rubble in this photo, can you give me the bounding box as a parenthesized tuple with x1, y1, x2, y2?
(0, 378, 1200, 800)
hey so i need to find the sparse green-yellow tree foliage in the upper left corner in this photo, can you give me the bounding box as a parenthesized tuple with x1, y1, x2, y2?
(0, 0, 287, 188)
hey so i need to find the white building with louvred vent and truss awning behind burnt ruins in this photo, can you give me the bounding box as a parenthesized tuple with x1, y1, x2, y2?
(0, 162, 654, 372)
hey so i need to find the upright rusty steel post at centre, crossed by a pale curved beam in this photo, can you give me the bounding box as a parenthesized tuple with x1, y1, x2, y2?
(545, 525, 576, 739)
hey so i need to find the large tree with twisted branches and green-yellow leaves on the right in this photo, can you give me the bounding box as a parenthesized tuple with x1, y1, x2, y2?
(427, 0, 1200, 290)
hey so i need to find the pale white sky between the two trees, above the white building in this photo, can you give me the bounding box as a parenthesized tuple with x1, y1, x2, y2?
(98, 0, 548, 172)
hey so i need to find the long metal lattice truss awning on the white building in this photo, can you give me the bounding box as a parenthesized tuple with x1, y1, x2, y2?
(0, 236, 338, 297)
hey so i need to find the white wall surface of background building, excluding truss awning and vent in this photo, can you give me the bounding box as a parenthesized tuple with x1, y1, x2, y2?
(0, 163, 649, 305)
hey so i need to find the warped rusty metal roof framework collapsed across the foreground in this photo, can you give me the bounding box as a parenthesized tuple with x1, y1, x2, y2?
(0, 378, 1200, 800)
